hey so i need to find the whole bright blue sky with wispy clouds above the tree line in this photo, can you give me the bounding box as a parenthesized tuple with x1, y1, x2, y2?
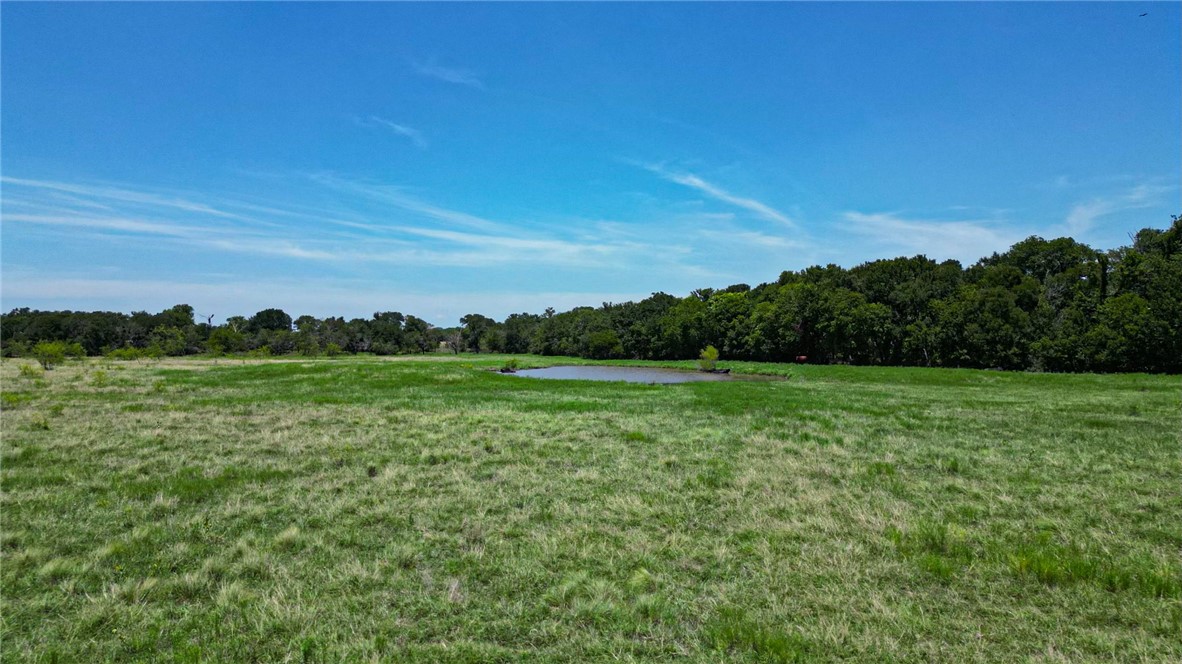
(0, 2, 1182, 325)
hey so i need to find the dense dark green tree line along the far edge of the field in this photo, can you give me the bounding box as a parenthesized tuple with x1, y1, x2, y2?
(0, 217, 1182, 372)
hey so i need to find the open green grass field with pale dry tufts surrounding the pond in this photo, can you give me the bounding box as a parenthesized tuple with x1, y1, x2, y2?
(0, 356, 1182, 662)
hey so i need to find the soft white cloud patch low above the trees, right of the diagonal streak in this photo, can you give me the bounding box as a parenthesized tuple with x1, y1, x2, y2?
(839, 211, 1022, 263)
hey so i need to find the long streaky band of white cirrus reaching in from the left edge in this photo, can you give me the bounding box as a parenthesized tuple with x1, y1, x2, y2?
(4, 175, 690, 268)
